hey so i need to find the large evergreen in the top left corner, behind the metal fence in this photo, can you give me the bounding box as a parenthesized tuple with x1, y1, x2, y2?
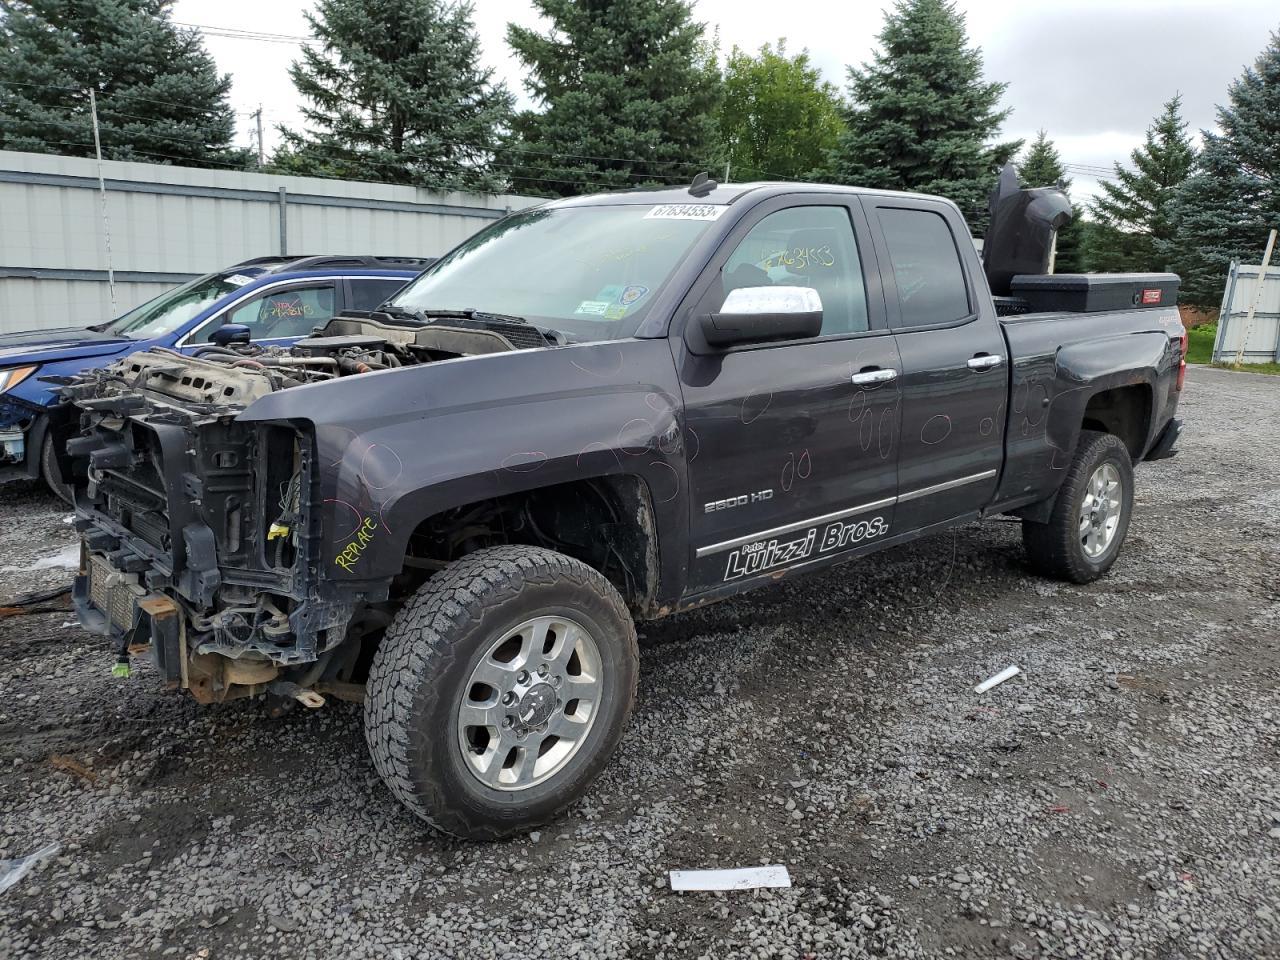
(0, 0, 247, 166)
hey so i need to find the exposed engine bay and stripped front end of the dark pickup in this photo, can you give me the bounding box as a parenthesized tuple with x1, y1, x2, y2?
(60, 315, 556, 703)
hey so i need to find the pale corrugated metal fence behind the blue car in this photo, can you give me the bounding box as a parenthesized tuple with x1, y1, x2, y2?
(0, 151, 540, 333)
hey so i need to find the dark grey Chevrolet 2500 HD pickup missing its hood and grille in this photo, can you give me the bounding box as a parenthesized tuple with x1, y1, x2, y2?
(61, 174, 1187, 838)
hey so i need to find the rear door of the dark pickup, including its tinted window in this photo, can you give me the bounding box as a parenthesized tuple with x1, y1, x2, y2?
(863, 197, 1009, 530)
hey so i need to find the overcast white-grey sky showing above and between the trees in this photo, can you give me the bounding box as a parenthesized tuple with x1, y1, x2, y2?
(173, 0, 1280, 197)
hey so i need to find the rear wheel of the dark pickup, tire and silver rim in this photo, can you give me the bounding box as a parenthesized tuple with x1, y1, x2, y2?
(1023, 430, 1133, 584)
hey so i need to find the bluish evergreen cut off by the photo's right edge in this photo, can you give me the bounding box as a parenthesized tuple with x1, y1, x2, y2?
(1170, 33, 1280, 308)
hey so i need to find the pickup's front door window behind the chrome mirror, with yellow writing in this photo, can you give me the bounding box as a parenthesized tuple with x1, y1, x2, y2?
(721, 206, 868, 337)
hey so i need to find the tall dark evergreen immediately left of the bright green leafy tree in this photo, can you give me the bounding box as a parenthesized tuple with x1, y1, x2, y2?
(507, 0, 719, 196)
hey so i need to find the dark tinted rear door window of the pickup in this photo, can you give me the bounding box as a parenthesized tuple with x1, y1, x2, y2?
(878, 207, 970, 326)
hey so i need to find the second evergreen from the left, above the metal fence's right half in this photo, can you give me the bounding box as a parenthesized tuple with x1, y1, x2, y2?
(273, 0, 513, 191)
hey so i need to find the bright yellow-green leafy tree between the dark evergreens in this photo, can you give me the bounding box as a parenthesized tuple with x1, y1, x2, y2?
(716, 40, 844, 182)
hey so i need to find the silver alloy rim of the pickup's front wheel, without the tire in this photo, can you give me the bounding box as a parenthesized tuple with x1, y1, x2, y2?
(458, 617, 603, 791)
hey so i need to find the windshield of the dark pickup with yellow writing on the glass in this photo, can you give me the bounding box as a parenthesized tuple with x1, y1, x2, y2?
(392, 204, 726, 340)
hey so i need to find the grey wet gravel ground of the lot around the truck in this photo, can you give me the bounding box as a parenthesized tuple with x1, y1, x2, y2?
(0, 369, 1280, 960)
